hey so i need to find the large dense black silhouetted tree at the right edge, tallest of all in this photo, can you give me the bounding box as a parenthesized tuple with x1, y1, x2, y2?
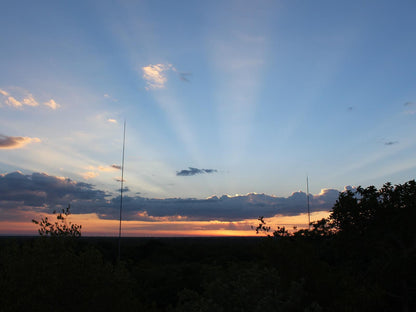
(320, 180, 416, 311)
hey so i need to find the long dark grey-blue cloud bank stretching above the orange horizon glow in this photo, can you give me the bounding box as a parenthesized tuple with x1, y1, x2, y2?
(0, 171, 339, 222)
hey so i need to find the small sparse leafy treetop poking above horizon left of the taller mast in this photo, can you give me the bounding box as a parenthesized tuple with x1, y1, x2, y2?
(32, 205, 82, 237)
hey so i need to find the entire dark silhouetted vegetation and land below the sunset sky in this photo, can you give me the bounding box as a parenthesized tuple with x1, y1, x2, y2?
(0, 181, 416, 312)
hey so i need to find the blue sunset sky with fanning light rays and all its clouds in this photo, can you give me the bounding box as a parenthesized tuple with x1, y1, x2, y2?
(0, 0, 416, 236)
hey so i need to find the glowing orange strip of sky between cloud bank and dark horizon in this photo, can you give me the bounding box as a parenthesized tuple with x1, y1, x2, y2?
(0, 211, 329, 237)
